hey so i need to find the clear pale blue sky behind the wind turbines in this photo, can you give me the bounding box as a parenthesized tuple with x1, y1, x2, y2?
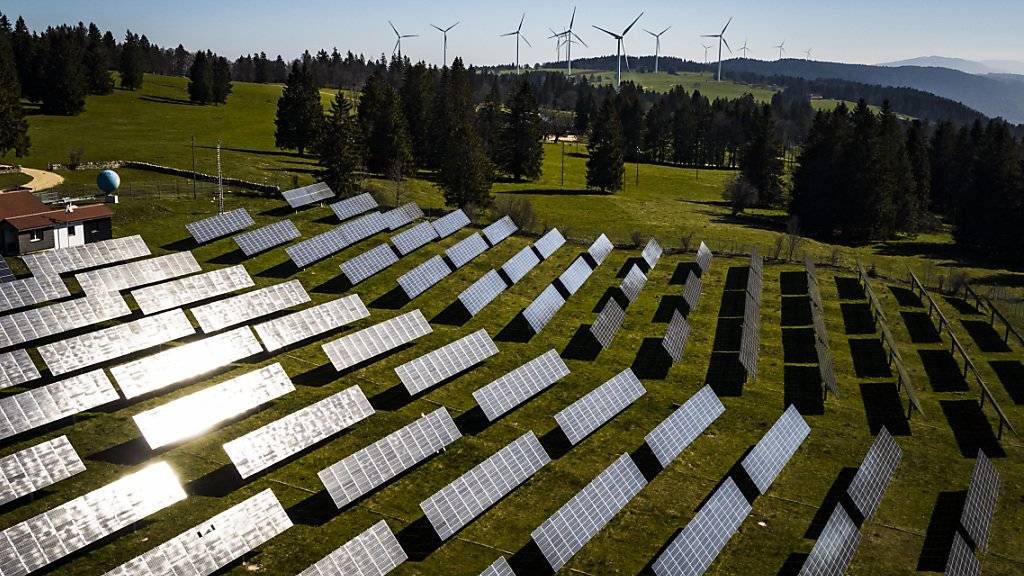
(8, 0, 1024, 65)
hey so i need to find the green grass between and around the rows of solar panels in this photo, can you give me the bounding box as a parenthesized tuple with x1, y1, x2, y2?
(2, 190, 1024, 576)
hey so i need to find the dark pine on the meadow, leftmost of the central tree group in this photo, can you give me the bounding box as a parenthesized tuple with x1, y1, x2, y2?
(273, 63, 324, 156)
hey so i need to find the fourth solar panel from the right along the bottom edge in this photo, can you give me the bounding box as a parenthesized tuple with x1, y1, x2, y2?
(530, 454, 647, 572)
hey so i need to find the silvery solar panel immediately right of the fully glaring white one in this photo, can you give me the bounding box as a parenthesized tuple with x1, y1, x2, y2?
(224, 386, 374, 478)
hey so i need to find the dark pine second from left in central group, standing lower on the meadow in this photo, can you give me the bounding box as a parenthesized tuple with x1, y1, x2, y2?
(315, 90, 362, 196)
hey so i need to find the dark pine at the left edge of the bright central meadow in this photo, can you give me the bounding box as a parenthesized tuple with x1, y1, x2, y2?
(499, 80, 544, 181)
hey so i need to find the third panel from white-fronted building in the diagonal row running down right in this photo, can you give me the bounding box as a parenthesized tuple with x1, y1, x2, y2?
(131, 265, 255, 315)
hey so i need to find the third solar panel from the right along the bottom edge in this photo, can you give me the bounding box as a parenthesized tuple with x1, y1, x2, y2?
(651, 478, 751, 576)
